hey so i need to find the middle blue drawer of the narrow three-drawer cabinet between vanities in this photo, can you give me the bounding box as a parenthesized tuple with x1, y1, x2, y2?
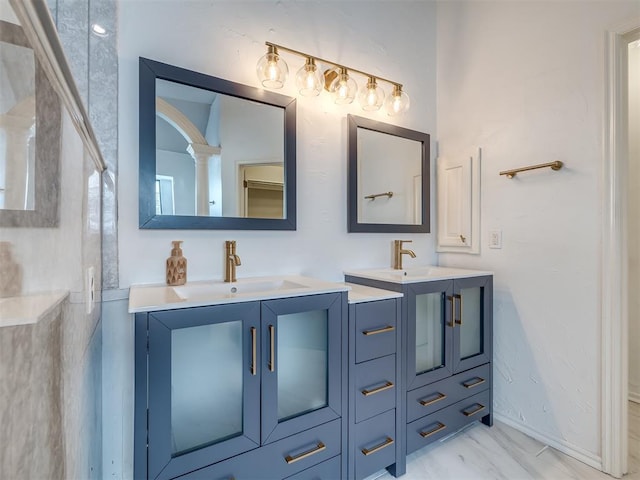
(354, 355, 397, 423)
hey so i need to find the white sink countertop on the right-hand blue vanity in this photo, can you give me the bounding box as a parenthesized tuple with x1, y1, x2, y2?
(344, 265, 491, 283)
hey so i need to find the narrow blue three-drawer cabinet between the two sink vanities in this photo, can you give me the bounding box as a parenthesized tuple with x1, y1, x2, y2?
(347, 292, 406, 480)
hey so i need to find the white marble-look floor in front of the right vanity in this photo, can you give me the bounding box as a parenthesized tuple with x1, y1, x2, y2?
(368, 402, 640, 480)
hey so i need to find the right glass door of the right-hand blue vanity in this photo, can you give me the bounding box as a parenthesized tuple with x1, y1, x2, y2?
(453, 277, 492, 372)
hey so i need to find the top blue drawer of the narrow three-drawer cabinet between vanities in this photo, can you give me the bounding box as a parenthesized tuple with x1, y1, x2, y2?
(355, 300, 397, 363)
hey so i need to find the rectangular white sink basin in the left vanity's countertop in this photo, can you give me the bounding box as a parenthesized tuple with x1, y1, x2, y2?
(171, 279, 309, 300)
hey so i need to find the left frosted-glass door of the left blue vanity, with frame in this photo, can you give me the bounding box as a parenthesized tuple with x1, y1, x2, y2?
(148, 303, 260, 478)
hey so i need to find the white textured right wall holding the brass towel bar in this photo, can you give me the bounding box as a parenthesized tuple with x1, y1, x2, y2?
(437, 1, 640, 466)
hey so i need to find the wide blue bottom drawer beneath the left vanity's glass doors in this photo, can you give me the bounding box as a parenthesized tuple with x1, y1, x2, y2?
(180, 420, 341, 480)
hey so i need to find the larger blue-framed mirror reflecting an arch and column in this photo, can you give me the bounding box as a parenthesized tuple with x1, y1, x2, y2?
(139, 58, 296, 230)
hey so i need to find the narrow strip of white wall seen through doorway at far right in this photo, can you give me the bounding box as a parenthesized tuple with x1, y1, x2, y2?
(627, 41, 640, 402)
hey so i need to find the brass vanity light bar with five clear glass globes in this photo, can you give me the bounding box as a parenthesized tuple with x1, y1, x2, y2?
(256, 42, 410, 116)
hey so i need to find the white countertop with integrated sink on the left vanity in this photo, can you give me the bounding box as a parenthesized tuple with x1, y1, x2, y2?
(129, 275, 349, 313)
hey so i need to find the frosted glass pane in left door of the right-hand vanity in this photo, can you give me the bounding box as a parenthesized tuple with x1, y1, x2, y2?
(416, 292, 444, 374)
